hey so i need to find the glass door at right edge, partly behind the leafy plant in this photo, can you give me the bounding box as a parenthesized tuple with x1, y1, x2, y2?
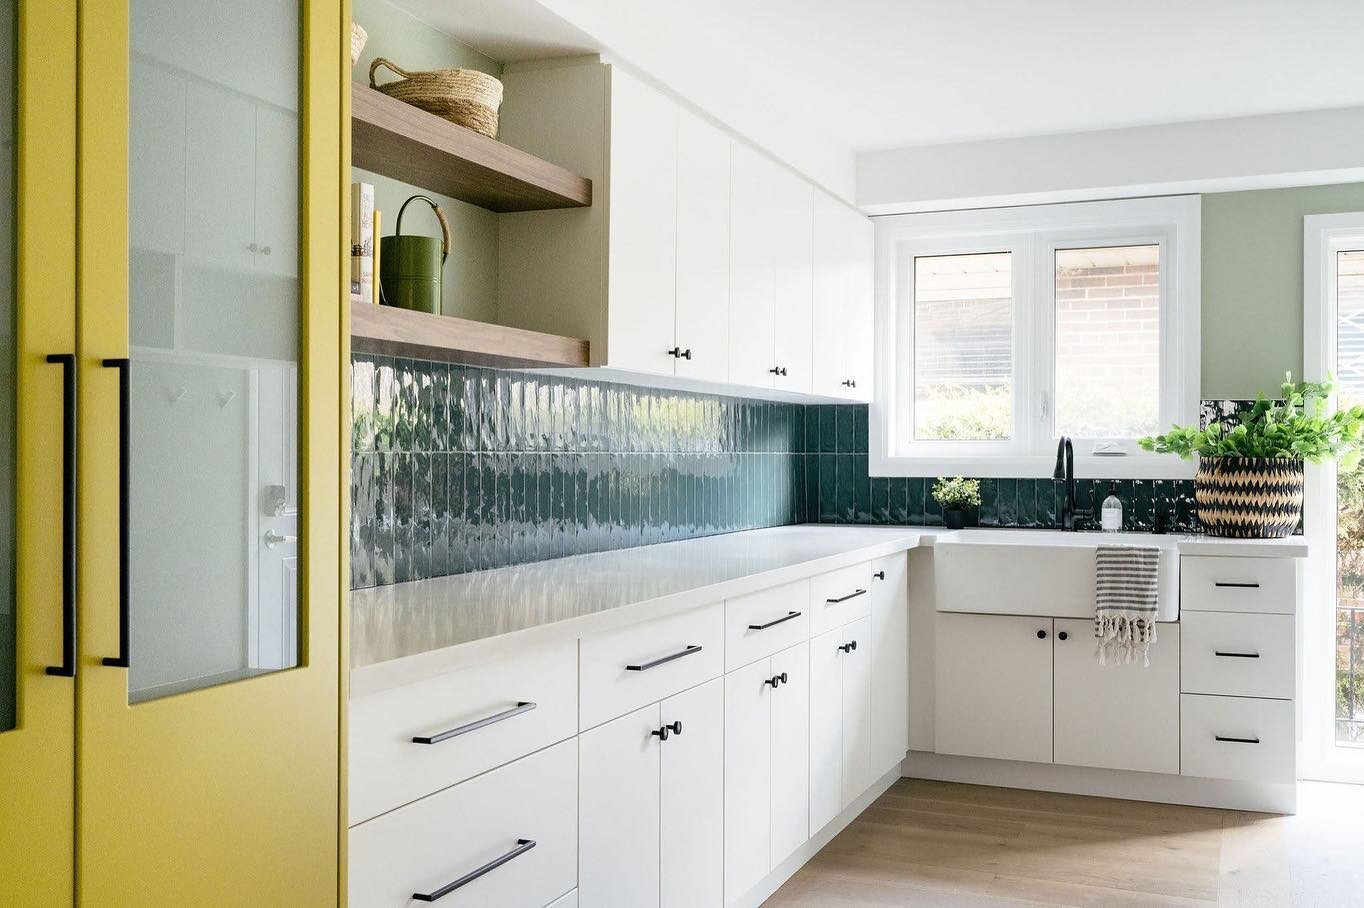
(1299, 214, 1364, 783)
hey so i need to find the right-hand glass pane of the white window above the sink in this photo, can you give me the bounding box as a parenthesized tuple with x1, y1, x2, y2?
(1056, 245, 1161, 438)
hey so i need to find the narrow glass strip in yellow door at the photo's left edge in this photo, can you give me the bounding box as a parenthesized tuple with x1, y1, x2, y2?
(0, 0, 19, 731)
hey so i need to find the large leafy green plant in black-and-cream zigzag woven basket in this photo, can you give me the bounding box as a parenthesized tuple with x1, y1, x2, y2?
(1139, 374, 1364, 539)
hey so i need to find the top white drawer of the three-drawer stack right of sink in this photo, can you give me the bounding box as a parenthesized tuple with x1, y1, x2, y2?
(1180, 555, 1297, 615)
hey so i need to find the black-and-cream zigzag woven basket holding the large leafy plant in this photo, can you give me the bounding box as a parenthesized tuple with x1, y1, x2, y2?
(1194, 457, 1303, 539)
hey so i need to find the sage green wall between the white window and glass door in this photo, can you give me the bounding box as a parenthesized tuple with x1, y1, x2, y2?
(1202, 183, 1364, 399)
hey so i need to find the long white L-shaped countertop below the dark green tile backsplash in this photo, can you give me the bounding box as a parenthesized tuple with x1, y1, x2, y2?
(351, 525, 1307, 695)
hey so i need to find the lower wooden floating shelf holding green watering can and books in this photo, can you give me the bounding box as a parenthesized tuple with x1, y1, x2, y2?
(351, 301, 588, 367)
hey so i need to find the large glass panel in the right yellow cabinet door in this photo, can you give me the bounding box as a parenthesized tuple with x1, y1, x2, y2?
(128, 0, 300, 702)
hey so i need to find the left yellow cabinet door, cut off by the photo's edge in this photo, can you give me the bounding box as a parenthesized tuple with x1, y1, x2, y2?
(0, 0, 76, 905)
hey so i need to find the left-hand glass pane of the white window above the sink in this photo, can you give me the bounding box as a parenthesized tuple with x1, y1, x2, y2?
(914, 252, 1013, 442)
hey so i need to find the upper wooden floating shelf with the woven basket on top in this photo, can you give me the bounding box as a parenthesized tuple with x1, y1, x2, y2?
(351, 82, 592, 213)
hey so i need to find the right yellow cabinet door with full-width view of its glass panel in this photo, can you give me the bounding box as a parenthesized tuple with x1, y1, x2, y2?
(76, 0, 349, 905)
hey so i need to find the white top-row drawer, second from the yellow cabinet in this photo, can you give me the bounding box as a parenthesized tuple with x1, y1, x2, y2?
(578, 603, 724, 729)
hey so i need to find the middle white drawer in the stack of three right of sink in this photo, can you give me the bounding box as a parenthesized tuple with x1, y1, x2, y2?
(1180, 612, 1294, 699)
